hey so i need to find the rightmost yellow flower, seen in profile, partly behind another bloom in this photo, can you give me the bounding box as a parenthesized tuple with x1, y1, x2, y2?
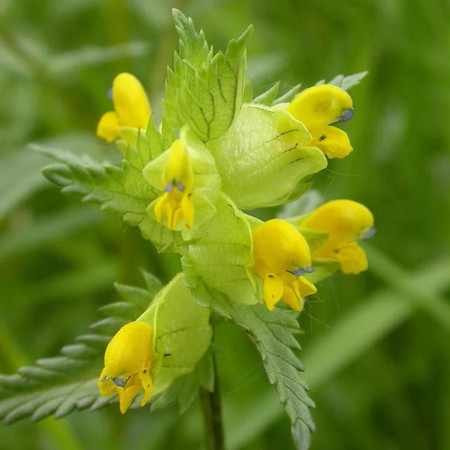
(300, 200, 375, 274)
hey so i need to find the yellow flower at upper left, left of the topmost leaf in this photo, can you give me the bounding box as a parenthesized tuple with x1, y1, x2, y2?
(97, 73, 151, 142)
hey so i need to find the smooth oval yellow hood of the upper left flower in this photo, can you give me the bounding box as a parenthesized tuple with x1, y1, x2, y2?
(112, 73, 151, 130)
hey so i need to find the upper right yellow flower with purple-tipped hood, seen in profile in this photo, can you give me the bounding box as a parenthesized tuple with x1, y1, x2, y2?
(287, 84, 353, 158)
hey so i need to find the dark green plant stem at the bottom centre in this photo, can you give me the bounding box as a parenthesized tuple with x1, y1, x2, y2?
(200, 353, 225, 450)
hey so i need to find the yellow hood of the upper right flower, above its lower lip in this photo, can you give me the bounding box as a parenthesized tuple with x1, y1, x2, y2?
(287, 84, 353, 139)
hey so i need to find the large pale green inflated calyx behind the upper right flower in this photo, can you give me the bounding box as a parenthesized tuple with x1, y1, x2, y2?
(207, 105, 327, 209)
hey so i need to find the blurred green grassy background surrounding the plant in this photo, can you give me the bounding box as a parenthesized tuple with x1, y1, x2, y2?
(0, 0, 450, 450)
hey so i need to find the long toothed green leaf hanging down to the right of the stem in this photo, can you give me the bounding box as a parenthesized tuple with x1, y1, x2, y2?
(207, 295, 314, 450)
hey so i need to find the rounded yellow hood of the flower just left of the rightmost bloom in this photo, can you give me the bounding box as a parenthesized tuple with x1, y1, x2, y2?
(253, 219, 311, 279)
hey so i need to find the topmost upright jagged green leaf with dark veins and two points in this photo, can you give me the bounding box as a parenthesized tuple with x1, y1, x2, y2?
(163, 10, 252, 142)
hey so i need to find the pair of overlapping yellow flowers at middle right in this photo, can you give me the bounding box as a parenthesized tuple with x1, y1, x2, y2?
(253, 200, 375, 311)
